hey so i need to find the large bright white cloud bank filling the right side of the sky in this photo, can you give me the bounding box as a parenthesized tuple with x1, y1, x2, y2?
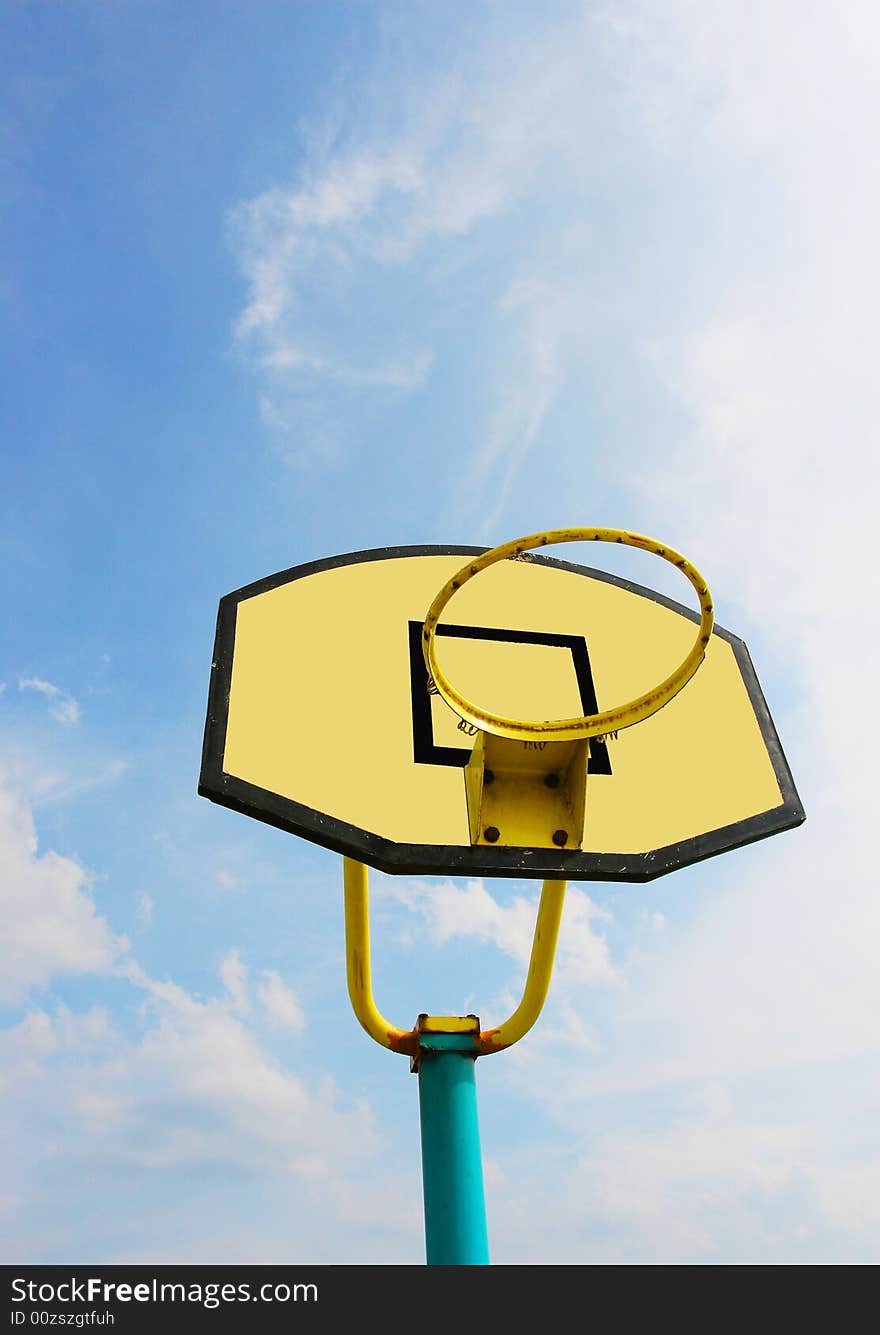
(429, 4, 880, 1259)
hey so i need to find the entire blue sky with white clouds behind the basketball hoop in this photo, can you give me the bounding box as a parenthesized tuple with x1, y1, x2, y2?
(0, 0, 880, 1264)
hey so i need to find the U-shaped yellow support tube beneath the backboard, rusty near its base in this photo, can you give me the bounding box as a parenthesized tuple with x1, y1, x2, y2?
(343, 857, 565, 1056)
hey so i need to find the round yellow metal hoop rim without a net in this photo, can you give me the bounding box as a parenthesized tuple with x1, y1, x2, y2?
(422, 529, 714, 742)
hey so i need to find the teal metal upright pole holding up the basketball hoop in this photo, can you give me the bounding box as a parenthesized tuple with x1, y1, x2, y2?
(415, 1033, 489, 1266)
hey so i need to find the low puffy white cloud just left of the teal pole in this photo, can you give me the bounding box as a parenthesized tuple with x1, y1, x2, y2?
(0, 964, 377, 1201)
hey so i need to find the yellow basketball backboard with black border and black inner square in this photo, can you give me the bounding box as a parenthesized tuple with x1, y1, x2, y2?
(199, 546, 804, 881)
